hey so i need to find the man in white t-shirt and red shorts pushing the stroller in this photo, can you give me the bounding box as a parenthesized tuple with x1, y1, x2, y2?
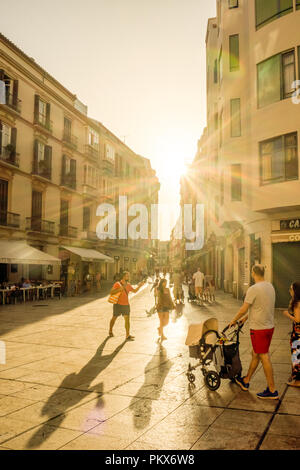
(230, 265, 279, 400)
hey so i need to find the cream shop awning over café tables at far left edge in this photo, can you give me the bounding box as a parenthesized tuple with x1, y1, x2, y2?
(0, 240, 61, 265)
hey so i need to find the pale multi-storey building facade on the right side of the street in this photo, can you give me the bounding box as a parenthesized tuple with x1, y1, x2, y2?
(180, 0, 300, 307)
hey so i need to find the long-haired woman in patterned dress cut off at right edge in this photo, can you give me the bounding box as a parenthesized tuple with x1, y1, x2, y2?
(283, 282, 300, 387)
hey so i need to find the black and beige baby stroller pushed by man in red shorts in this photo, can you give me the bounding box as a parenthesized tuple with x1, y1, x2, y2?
(185, 318, 243, 391)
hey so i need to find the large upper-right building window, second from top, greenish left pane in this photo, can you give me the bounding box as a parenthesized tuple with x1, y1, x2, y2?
(257, 50, 296, 108)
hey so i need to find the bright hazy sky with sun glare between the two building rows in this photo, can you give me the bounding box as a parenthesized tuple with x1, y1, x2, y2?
(0, 0, 216, 240)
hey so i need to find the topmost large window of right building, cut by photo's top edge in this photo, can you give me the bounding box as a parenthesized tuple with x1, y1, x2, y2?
(255, 0, 293, 28)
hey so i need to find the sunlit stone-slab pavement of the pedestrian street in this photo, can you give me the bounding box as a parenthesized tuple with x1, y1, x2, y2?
(0, 280, 300, 450)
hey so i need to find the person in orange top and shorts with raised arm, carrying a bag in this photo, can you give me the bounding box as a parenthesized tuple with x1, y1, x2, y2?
(109, 271, 144, 341)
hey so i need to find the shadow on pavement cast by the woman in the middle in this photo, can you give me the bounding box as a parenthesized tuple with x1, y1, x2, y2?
(129, 345, 172, 429)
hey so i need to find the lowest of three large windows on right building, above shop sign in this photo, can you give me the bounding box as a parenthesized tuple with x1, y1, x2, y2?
(260, 132, 298, 184)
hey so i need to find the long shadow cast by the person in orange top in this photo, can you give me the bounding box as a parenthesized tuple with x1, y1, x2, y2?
(26, 336, 126, 449)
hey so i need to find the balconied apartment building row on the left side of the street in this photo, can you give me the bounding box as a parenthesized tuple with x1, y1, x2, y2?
(0, 35, 159, 285)
